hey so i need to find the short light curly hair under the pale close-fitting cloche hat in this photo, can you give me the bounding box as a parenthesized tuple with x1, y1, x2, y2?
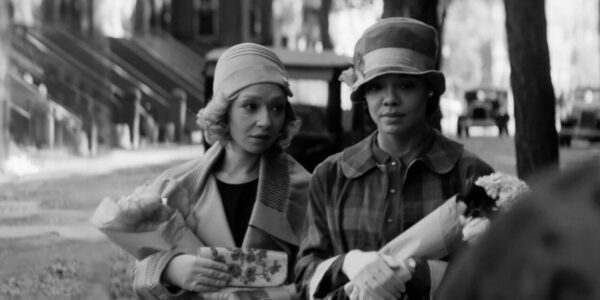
(196, 93, 301, 149)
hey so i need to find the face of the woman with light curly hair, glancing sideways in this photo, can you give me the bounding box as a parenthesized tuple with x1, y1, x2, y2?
(228, 83, 287, 154)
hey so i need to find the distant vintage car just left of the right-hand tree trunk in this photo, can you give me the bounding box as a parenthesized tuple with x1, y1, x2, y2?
(456, 87, 509, 137)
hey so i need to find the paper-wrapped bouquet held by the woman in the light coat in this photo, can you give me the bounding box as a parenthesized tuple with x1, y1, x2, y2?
(90, 181, 203, 260)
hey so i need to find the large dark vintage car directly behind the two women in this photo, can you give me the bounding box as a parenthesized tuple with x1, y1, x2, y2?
(204, 48, 366, 171)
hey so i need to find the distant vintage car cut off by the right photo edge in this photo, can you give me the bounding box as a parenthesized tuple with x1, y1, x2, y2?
(559, 87, 600, 146)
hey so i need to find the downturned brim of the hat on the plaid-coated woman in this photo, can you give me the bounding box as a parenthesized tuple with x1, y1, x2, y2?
(350, 68, 446, 102)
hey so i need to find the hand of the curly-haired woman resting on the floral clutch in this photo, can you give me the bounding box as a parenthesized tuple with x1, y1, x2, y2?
(163, 254, 231, 293)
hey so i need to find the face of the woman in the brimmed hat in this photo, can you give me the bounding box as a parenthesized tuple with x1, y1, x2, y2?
(364, 74, 428, 135)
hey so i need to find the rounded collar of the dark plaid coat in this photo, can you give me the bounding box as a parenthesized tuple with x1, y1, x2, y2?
(341, 130, 463, 178)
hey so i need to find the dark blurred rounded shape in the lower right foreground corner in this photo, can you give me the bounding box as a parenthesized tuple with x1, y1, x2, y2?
(436, 161, 600, 300)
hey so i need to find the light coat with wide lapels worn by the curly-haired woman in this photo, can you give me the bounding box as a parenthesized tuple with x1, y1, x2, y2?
(132, 143, 310, 300)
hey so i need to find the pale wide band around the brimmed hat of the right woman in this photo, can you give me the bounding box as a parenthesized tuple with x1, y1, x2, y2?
(361, 47, 434, 74)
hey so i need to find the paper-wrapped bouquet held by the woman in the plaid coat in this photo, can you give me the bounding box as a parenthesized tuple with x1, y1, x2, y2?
(380, 172, 529, 260)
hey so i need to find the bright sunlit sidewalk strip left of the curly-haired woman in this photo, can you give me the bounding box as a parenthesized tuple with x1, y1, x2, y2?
(0, 145, 204, 184)
